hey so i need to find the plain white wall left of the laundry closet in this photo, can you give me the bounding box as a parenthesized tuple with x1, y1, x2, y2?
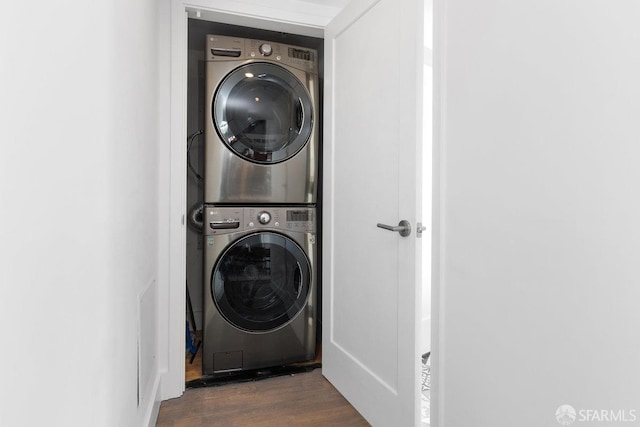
(0, 0, 165, 426)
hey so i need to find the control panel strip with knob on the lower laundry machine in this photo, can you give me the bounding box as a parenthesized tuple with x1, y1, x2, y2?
(203, 206, 316, 235)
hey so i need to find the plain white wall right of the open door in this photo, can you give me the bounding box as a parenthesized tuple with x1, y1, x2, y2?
(434, 0, 640, 427)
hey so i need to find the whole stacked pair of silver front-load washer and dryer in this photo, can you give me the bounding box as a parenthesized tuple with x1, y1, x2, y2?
(203, 35, 319, 374)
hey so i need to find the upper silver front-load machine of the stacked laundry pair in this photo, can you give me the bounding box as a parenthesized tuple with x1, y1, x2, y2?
(205, 34, 319, 205)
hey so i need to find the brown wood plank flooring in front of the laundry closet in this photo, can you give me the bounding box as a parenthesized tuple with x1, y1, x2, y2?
(156, 369, 369, 427)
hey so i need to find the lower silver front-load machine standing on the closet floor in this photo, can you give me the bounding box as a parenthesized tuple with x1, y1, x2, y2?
(202, 206, 317, 374)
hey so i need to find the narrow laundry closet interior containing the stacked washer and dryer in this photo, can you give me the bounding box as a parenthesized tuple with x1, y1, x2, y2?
(185, 19, 323, 382)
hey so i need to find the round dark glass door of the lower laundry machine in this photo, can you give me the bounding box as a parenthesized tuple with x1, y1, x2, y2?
(211, 232, 311, 332)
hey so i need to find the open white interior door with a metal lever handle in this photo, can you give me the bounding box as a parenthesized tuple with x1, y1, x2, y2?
(322, 0, 422, 426)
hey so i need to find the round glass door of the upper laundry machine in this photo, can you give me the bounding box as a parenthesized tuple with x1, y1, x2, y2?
(212, 62, 313, 164)
